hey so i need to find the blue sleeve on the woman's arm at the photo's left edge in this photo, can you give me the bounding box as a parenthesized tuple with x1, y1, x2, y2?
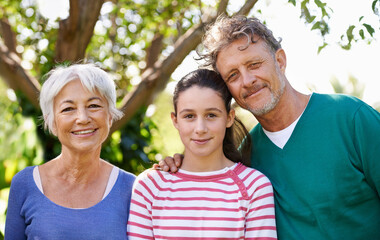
(4, 175, 26, 240)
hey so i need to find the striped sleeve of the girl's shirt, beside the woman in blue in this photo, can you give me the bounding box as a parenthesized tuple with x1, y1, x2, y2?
(127, 174, 154, 240)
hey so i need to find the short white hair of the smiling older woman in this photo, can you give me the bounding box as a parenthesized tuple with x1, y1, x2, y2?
(40, 64, 123, 132)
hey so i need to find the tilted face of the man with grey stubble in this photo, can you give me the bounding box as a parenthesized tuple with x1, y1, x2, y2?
(216, 37, 286, 116)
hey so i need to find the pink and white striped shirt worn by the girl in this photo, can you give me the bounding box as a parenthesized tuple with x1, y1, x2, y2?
(128, 163, 277, 240)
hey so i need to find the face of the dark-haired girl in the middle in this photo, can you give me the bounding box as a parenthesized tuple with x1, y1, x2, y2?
(171, 86, 235, 159)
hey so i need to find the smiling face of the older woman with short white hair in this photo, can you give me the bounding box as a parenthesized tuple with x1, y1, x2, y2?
(53, 79, 112, 152)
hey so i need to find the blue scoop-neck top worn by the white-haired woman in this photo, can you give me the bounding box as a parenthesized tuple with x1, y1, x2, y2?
(5, 167, 135, 240)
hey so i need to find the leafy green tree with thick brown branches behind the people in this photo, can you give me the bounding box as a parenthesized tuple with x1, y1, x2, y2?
(0, 0, 380, 237)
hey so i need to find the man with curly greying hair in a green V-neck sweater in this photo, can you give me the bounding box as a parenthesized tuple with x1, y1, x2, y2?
(160, 16, 380, 240)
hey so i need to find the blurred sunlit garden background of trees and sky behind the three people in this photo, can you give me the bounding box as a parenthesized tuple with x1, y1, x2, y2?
(0, 0, 380, 236)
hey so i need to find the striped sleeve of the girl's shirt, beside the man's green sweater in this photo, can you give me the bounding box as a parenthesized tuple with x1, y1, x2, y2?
(244, 174, 277, 240)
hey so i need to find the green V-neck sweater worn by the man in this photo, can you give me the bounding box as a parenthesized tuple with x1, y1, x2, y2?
(250, 93, 380, 240)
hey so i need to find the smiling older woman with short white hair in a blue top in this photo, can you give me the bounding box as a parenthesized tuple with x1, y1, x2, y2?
(5, 64, 135, 240)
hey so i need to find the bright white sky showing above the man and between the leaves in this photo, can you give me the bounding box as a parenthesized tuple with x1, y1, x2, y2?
(38, 0, 380, 105)
